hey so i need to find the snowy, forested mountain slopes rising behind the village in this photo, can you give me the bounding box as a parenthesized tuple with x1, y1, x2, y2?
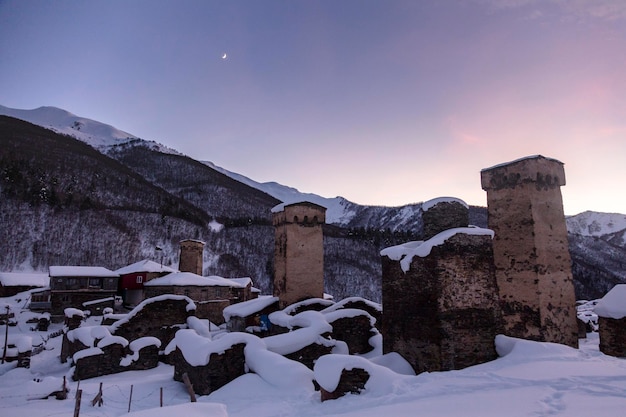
(0, 106, 626, 300)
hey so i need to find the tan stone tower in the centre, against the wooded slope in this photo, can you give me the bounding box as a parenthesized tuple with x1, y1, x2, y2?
(272, 201, 326, 309)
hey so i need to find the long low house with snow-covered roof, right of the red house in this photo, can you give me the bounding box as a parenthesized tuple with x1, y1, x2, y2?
(144, 272, 247, 324)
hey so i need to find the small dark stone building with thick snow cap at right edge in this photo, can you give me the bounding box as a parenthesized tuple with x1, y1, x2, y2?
(593, 284, 626, 358)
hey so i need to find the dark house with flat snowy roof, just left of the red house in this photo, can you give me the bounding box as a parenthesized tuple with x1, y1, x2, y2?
(49, 266, 120, 318)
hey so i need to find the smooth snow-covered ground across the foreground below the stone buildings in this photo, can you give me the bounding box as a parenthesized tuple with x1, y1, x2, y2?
(0, 295, 626, 417)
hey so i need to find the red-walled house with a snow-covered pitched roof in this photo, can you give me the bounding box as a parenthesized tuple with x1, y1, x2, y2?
(115, 259, 177, 306)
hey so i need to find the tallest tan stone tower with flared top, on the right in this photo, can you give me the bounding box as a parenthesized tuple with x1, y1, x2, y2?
(481, 155, 578, 347)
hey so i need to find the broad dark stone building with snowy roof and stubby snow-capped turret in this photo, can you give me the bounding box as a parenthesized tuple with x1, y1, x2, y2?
(381, 198, 501, 373)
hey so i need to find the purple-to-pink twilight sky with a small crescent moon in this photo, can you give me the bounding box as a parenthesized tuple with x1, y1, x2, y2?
(0, 0, 626, 214)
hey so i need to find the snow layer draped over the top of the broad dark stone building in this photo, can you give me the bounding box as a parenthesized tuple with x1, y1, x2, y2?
(380, 227, 493, 272)
